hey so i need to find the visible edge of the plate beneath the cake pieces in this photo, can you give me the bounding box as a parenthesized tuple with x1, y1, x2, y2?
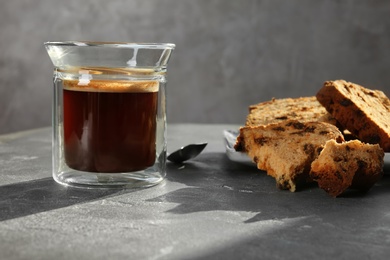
(223, 130, 390, 170)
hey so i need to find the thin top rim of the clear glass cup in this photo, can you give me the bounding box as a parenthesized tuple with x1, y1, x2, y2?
(44, 41, 176, 49)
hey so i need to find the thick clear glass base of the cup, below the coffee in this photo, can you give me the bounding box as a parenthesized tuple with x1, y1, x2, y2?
(53, 169, 164, 189)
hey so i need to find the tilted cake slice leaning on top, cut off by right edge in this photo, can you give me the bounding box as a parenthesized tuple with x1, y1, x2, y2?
(316, 80, 390, 152)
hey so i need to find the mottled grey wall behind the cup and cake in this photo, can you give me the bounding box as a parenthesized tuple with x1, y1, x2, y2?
(0, 0, 390, 133)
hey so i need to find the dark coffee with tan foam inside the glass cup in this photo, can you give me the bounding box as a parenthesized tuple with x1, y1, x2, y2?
(63, 80, 158, 173)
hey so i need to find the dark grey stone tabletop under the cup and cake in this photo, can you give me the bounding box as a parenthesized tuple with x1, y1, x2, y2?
(0, 125, 390, 259)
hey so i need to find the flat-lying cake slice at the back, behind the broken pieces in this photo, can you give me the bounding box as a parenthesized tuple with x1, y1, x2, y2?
(245, 96, 337, 126)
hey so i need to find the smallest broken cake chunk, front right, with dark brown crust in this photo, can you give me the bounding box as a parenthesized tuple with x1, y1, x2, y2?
(310, 140, 384, 197)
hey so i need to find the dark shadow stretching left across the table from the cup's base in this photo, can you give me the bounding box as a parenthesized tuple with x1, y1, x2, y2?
(0, 177, 128, 221)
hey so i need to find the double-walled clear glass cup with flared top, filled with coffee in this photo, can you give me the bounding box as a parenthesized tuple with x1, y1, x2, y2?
(45, 42, 175, 188)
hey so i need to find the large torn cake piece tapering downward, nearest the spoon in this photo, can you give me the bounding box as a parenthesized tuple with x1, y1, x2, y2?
(234, 120, 344, 191)
